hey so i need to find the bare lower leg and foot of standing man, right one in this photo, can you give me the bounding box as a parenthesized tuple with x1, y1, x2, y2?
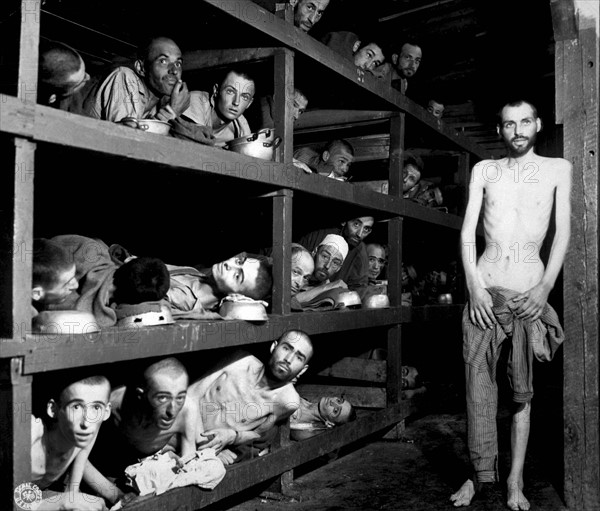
(507, 403, 531, 511)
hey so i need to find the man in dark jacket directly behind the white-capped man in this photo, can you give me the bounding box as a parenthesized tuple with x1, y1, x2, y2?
(299, 216, 375, 298)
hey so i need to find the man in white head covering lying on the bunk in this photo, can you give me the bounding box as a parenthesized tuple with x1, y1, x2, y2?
(294, 234, 349, 308)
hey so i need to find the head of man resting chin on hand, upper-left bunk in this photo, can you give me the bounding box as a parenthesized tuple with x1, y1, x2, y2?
(134, 37, 183, 98)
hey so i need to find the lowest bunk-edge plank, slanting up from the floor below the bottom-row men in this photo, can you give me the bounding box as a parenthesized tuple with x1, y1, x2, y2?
(127, 401, 412, 511)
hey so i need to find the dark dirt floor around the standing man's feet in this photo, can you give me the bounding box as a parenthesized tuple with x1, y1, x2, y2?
(211, 380, 566, 511)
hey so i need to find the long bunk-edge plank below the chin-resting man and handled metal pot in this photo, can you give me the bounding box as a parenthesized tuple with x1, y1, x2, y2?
(0, 96, 403, 215)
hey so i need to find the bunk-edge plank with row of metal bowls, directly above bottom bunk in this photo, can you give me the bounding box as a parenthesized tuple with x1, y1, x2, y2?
(17, 307, 402, 374)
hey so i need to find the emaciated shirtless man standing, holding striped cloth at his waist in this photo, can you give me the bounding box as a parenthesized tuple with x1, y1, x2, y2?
(450, 101, 571, 510)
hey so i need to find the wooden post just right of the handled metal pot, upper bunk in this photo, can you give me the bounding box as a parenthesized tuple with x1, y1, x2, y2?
(273, 48, 294, 164)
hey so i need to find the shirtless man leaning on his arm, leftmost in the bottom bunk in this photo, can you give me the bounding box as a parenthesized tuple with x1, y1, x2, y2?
(31, 376, 110, 511)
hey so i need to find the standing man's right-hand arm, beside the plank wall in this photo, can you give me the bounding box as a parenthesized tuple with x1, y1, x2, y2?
(513, 160, 573, 321)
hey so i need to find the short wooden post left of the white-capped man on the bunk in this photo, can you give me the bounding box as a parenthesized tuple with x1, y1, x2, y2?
(271, 189, 293, 314)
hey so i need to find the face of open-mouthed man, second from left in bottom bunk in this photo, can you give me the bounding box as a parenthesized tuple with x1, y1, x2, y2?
(145, 371, 188, 430)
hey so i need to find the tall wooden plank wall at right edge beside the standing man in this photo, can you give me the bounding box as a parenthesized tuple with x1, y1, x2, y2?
(551, 0, 600, 511)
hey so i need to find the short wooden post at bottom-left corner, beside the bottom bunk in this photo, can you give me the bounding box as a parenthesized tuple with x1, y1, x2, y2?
(0, 358, 32, 509)
